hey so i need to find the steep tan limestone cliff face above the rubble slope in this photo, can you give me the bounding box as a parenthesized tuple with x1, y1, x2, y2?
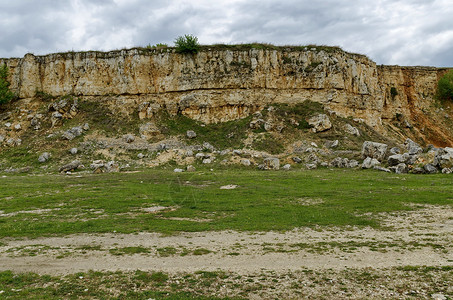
(0, 47, 453, 146)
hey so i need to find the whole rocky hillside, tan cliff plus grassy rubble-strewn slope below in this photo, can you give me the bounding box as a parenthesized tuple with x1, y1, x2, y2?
(0, 44, 453, 175)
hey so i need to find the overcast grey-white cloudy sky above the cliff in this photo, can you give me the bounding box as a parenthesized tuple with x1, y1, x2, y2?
(0, 0, 453, 67)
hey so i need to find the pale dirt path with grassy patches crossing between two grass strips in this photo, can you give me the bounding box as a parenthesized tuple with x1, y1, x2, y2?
(0, 207, 453, 274)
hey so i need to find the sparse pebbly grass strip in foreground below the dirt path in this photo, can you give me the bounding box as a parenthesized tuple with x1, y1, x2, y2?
(0, 266, 453, 300)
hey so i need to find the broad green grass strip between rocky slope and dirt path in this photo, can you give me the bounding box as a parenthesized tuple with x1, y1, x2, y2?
(0, 169, 453, 238)
